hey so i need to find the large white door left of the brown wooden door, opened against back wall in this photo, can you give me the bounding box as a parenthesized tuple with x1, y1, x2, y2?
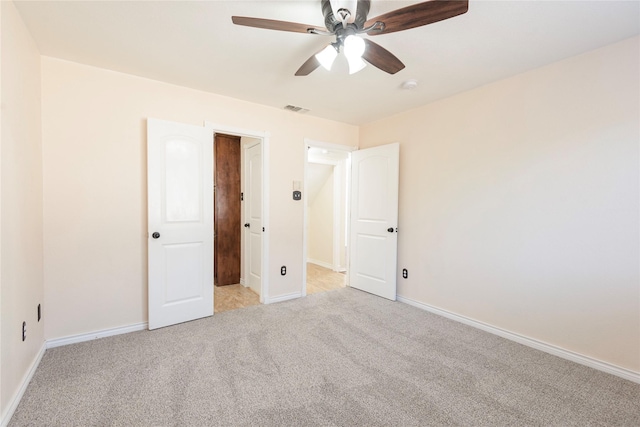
(147, 119, 213, 329)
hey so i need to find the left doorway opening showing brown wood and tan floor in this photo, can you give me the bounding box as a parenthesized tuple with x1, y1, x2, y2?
(210, 123, 268, 313)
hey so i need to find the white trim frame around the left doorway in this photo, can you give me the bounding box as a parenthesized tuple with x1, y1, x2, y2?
(204, 121, 270, 304)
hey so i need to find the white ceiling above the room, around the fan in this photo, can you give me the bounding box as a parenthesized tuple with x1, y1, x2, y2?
(15, 0, 640, 124)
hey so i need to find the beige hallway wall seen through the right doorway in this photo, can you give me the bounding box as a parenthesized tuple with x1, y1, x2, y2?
(307, 163, 334, 268)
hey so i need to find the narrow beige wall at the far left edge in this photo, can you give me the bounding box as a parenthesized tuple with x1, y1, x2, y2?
(0, 1, 47, 420)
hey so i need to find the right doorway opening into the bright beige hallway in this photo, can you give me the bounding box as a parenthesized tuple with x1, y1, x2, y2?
(302, 140, 354, 295)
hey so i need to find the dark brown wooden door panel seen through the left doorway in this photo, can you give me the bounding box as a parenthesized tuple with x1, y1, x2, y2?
(213, 133, 242, 286)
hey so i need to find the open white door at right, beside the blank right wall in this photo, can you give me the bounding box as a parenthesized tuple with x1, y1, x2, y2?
(349, 143, 400, 301)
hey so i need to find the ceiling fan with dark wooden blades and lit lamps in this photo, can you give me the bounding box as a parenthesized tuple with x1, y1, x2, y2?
(231, 0, 469, 76)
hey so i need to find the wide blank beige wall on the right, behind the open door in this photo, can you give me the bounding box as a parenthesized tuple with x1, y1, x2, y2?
(360, 37, 640, 372)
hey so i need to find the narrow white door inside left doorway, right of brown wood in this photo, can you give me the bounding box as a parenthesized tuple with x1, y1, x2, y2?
(244, 144, 262, 296)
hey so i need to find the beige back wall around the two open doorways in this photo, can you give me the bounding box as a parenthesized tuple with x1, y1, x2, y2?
(42, 57, 358, 339)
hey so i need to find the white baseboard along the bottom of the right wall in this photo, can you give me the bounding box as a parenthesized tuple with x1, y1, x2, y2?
(397, 295, 640, 383)
